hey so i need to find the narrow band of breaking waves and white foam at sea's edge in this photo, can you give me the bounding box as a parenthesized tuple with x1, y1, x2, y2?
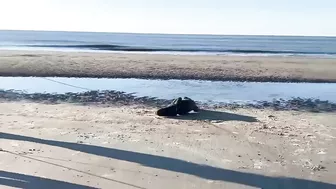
(0, 44, 336, 60)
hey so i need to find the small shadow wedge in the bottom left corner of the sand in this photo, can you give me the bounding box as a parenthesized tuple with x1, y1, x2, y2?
(0, 171, 95, 189)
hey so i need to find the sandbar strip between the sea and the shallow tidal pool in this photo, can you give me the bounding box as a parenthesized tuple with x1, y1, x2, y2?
(0, 51, 336, 82)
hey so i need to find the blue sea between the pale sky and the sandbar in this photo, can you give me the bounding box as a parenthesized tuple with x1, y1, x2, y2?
(0, 30, 336, 58)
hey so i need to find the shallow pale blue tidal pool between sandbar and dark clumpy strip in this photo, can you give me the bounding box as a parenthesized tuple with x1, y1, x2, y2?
(0, 77, 336, 103)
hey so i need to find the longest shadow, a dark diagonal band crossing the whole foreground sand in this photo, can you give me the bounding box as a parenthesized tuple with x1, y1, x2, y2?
(0, 132, 336, 189)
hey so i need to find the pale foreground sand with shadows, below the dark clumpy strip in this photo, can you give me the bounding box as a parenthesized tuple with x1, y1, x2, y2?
(0, 101, 336, 189)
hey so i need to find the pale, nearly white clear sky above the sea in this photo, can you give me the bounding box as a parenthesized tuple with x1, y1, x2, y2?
(0, 0, 336, 36)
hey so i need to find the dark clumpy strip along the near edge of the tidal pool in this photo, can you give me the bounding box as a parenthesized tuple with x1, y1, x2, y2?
(0, 90, 336, 113)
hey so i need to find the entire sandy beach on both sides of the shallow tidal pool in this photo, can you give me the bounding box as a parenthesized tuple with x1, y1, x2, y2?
(0, 51, 336, 189)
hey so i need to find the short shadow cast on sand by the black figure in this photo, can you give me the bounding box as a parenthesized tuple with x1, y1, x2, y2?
(168, 110, 258, 122)
